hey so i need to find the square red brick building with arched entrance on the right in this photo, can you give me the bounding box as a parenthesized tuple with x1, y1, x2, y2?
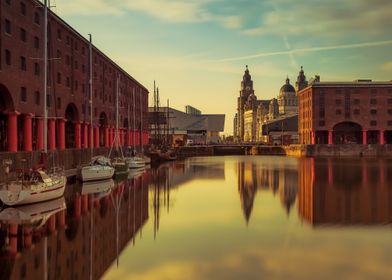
(298, 80, 392, 144)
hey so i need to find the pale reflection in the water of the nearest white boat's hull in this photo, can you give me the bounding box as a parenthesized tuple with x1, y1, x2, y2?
(0, 197, 66, 225)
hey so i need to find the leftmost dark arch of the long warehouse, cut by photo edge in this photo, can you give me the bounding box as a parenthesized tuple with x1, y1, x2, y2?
(0, 84, 15, 152)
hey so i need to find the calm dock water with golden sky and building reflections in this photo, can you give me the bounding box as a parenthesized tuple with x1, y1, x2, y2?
(0, 156, 392, 279)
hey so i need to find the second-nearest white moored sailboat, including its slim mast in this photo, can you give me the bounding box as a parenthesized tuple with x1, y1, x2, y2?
(78, 34, 114, 182)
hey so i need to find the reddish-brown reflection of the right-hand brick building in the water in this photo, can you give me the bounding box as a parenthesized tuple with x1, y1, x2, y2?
(297, 158, 392, 225)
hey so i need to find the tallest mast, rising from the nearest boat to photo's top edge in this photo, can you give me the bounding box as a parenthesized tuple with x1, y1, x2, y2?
(43, 0, 48, 154)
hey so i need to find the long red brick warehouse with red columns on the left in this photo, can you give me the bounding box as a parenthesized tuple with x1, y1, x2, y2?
(0, 0, 148, 152)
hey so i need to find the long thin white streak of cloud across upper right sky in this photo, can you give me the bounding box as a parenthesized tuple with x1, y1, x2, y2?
(219, 40, 392, 61)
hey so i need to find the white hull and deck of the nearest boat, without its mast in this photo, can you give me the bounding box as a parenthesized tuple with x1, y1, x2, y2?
(0, 169, 67, 206)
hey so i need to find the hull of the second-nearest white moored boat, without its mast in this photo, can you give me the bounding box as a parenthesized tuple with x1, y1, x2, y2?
(79, 156, 114, 182)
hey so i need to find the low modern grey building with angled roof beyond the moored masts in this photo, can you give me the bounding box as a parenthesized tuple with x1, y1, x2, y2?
(149, 107, 225, 146)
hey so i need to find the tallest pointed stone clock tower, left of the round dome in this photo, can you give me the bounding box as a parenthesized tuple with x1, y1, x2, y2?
(236, 65, 254, 141)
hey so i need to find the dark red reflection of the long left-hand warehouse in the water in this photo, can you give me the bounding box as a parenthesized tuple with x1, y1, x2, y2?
(0, 173, 149, 279)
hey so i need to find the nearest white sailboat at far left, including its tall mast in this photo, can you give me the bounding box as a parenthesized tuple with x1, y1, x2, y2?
(0, 0, 67, 206)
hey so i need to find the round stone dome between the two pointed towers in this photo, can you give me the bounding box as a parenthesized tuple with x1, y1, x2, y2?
(278, 77, 298, 115)
